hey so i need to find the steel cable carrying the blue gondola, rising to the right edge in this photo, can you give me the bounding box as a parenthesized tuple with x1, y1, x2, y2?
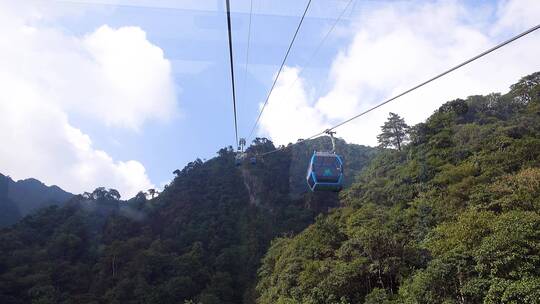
(259, 24, 540, 156)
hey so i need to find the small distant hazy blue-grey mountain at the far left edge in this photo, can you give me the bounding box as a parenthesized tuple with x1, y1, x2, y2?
(0, 174, 73, 227)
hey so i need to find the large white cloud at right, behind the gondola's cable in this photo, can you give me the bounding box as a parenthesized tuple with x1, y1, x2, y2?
(260, 0, 540, 145)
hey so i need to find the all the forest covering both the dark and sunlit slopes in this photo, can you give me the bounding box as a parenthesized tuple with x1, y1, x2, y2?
(0, 73, 540, 304)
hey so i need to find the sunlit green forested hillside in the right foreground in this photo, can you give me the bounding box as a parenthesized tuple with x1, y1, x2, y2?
(257, 73, 540, 304)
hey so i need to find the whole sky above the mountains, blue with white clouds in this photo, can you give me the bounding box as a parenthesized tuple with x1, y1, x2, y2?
(0, 0, 540, 197)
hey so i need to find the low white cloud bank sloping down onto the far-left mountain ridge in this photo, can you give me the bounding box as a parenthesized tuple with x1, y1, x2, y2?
(0, 86, 153, 197)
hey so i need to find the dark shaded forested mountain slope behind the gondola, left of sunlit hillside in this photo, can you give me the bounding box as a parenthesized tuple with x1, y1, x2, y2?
(0, 138, 375, 304)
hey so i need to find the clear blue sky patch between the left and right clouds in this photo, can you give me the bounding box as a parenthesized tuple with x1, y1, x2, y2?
(47, 0, 358, 188)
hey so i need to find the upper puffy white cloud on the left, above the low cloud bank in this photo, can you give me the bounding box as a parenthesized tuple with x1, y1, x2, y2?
(8, 25, 176, 129)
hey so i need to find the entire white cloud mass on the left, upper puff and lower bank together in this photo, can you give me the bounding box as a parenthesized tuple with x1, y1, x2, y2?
(0, 3, 176, 197)
